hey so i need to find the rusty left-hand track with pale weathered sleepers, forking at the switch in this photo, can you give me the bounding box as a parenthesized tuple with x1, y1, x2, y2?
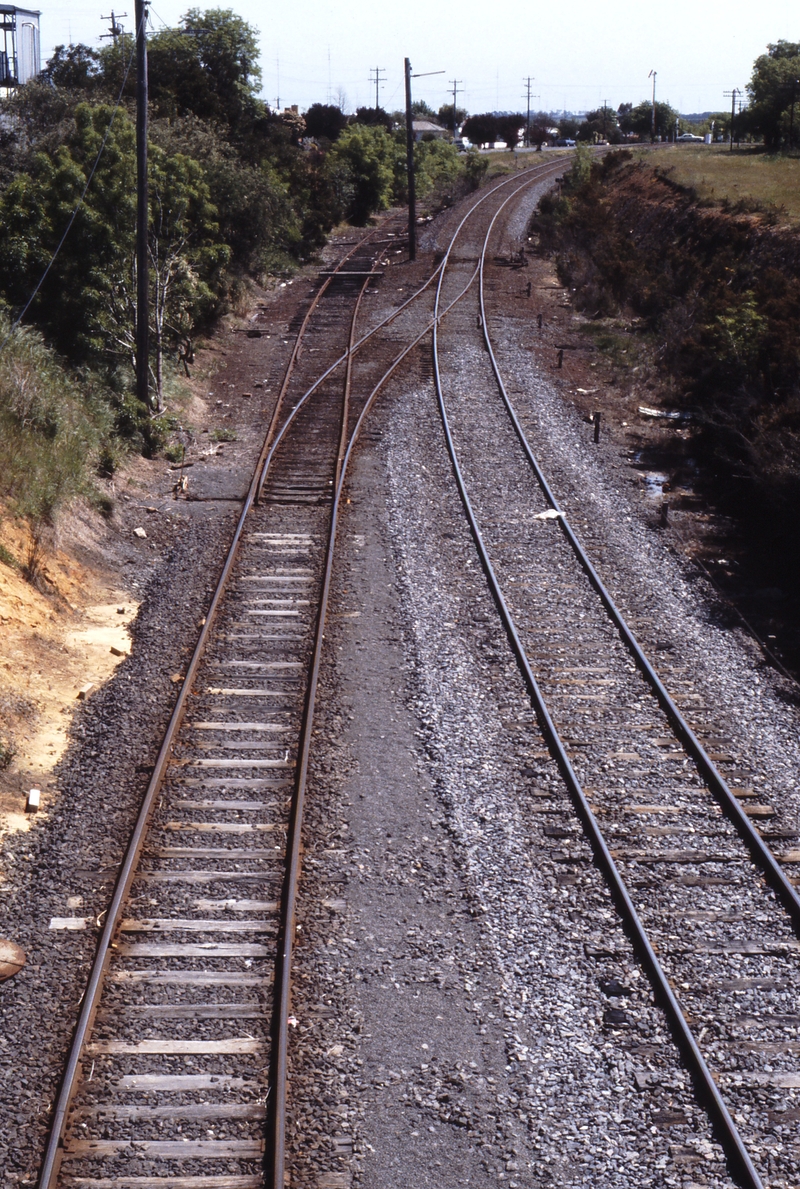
(34, 162, 561, 1189)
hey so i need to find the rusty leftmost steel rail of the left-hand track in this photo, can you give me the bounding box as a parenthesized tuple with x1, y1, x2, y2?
(38, 227, 382, 1189)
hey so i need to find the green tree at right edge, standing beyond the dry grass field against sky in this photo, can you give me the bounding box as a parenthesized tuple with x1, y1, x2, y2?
(747, 42, 800, 152)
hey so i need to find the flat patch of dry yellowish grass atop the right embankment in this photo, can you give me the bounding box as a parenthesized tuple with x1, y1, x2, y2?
(645, 145, 800, 222)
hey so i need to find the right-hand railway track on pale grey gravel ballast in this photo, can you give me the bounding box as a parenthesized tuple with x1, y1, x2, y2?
(434, 162, 800, 1189)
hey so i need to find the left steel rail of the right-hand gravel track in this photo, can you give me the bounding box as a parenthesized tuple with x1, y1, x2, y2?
(433, 173, 764, 1189)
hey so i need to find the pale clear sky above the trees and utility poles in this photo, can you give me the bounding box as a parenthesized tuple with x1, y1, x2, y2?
(35, 0, 800, 113)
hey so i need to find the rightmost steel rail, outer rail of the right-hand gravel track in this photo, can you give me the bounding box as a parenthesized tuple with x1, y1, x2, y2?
(479, 183, 800, 927)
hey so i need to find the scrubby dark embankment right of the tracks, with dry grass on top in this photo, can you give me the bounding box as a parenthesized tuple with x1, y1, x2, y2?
(531, 145, 800, 613)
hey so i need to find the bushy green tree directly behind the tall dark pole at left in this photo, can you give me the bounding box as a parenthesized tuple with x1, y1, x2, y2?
(0, 103, 229, 408)
